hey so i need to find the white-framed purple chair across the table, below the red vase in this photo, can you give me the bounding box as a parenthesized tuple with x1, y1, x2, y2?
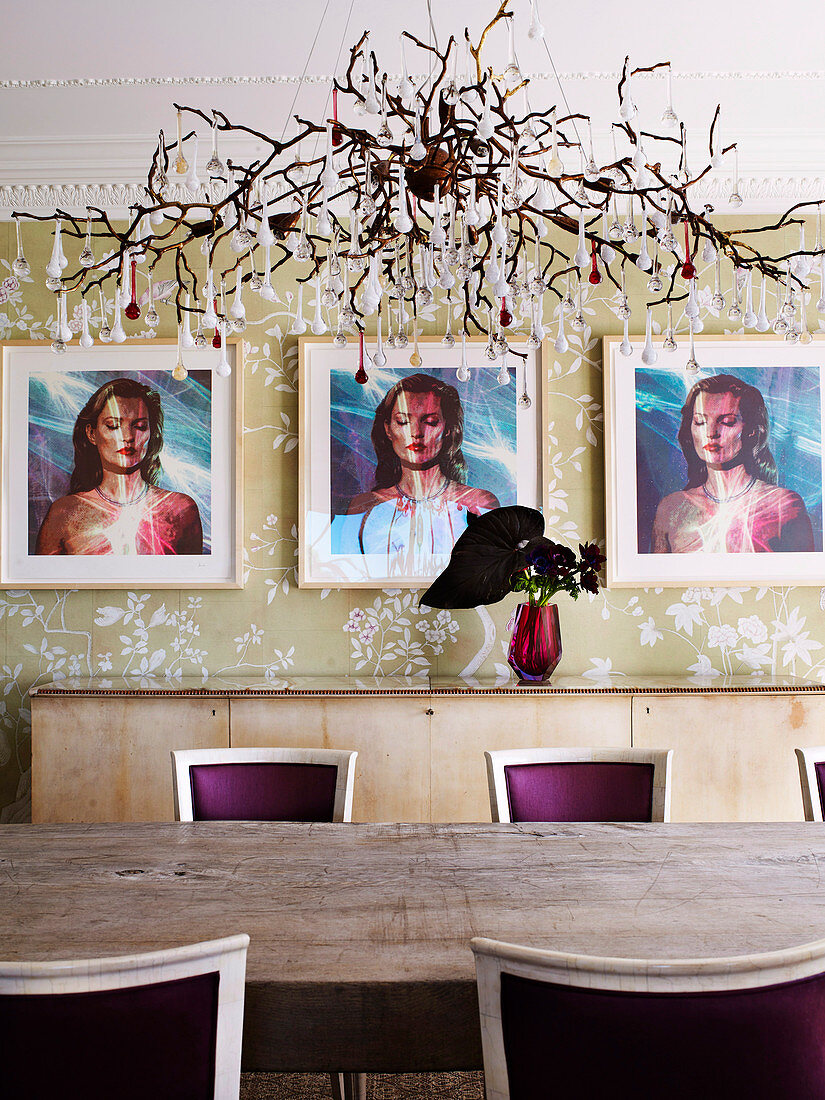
(484, 748, 673, 822)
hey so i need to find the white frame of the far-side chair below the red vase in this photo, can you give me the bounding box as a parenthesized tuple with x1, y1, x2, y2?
(484, 748, 673, 822)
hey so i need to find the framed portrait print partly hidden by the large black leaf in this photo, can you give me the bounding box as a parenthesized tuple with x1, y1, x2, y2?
(298, 338, 541, 589)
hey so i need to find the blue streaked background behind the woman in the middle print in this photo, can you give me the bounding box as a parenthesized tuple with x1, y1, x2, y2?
(330, 366, 518, 516)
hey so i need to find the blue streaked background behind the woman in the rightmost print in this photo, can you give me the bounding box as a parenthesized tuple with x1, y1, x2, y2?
(636, 366, 823, 553)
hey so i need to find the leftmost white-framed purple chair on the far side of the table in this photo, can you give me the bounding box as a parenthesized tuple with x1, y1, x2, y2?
(172, 748, 358, 822)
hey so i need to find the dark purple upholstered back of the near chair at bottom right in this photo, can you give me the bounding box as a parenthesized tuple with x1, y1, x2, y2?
(501, 974, 825, 1100)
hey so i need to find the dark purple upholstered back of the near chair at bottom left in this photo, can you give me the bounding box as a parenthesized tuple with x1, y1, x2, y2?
(0, 972, 219, 1100)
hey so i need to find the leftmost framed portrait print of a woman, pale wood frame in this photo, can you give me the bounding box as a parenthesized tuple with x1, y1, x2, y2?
(0, 339, 243, 589)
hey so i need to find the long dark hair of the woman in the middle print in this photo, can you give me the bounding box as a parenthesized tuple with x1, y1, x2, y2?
(370, 374, 466, 490)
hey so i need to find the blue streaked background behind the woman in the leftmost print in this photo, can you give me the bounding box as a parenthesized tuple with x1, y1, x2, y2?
(29, 370, 212, 554)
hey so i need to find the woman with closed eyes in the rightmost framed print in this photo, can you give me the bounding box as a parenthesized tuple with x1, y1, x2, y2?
(651, 374, 815, 553)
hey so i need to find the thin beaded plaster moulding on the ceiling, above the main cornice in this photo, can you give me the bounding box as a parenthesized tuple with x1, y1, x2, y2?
(0, 69, 825, 91)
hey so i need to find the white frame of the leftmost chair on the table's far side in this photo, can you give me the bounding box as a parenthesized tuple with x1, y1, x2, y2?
(172, 748, 358, 822)
